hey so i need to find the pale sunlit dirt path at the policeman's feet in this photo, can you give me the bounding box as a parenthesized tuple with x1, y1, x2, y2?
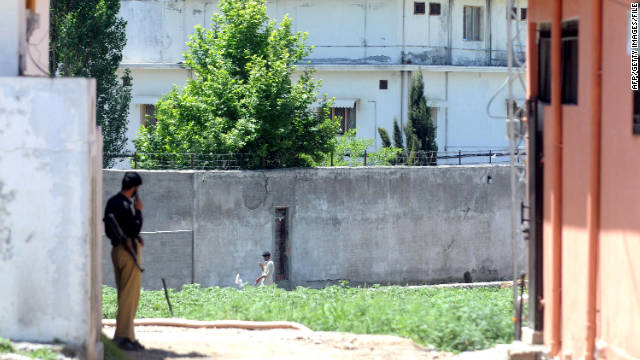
(103, 326, 452, 360)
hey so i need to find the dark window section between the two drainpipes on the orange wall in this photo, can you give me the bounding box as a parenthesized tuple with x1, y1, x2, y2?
(562, 20, 578, 104)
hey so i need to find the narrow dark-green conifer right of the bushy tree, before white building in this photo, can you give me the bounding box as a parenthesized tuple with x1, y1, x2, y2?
(405, 71, 438, 165)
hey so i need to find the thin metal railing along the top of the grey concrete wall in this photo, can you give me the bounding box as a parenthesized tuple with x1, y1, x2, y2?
(106, 149, 526, 170)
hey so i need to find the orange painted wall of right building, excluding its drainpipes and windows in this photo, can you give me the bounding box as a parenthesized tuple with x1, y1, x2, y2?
(528, 0, 640, 359)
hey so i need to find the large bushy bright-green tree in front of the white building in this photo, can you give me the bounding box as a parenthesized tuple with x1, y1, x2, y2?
(135, 0, 339, 167)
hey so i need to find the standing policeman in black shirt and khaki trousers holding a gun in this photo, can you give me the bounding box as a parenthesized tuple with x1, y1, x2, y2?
(104, 172, 144, 351)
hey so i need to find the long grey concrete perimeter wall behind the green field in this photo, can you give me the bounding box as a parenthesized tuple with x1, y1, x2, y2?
(103, 166, 525, 289)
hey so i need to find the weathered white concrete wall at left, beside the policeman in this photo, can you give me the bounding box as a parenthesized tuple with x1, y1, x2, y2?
(0, 77, 102, 359)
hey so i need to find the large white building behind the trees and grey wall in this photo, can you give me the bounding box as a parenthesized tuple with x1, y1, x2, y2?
(121, 0, 526, 160)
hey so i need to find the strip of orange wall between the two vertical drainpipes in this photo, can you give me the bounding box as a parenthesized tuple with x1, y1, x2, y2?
(562, 0, 593, 358)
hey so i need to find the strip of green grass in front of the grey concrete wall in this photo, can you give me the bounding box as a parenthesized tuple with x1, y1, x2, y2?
(103, 285, 513, 353)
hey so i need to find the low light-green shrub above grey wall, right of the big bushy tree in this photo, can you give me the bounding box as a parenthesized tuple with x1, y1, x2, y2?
(312, 129, 400, 166)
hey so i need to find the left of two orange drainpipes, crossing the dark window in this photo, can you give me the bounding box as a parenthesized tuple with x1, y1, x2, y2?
(549, 0, 562, 356)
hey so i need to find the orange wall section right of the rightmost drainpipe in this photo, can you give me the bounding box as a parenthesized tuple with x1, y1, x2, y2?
(598, 0, 640, 359)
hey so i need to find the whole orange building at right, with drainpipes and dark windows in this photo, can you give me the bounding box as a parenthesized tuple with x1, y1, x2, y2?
(527, 0, 640, 359)
